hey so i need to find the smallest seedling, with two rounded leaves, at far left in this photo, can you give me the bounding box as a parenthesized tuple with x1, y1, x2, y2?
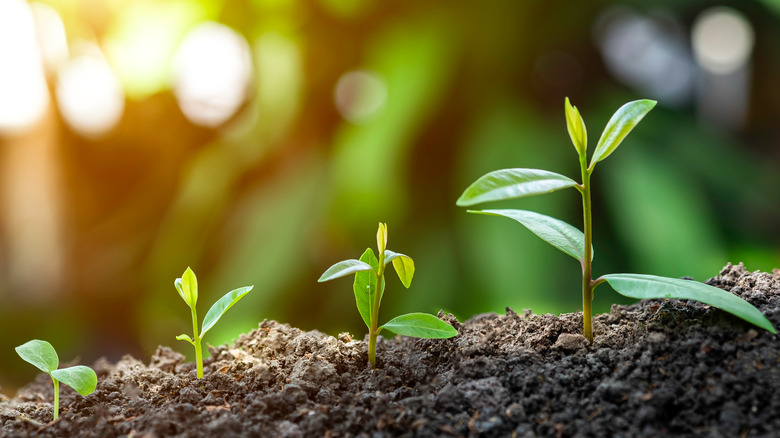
(16, 339, 97, 420)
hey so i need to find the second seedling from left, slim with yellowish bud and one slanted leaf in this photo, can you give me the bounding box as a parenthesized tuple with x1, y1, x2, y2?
(173, 267, 254, 379)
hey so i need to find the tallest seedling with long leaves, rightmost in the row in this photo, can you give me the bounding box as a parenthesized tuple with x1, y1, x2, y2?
(457, 98, 776, 342)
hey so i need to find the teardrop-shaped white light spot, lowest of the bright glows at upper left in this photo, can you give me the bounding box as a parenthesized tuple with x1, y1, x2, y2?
(56, 43, 125, 139)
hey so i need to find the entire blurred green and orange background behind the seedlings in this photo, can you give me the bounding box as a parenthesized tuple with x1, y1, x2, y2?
(0, 0, 780, 395)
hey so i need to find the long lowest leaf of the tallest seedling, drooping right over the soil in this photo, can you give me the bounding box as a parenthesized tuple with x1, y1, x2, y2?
(601, 274, 777, 333)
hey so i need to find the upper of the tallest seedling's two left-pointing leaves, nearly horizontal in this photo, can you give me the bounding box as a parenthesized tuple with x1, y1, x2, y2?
(456, 169, 577, 207)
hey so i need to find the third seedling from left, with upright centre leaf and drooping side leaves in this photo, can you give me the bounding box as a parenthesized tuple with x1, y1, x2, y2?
(317, 223, 458, 368)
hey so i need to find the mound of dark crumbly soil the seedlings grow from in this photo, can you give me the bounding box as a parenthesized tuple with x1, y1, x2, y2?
(0, 264, 780, 437)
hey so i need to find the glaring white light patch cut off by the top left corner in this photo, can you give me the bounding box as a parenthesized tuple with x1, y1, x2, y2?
(0, 0, 49, 134)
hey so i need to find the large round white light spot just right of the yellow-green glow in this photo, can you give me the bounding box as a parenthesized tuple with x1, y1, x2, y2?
(173, 22, 252, 127)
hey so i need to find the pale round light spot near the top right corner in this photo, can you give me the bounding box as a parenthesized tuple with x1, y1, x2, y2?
(692, 7, 755, 74)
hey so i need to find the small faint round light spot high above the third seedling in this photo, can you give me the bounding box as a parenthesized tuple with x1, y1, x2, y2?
(334, 70, 387, 124)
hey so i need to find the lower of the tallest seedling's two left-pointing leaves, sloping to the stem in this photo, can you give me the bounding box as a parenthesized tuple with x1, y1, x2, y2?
(469, 210, 593, 261)
